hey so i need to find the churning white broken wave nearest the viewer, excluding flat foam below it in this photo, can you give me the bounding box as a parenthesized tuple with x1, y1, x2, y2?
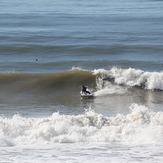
(0, 104, 163, 146)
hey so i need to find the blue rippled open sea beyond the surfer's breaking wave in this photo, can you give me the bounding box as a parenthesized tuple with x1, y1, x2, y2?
(0, 0, 163, 73)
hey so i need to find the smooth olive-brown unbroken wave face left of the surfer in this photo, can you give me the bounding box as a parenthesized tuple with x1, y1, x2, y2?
(0, 70, 95, 94)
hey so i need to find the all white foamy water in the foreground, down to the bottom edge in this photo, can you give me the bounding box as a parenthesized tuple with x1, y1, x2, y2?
(0, 104, 163, 162)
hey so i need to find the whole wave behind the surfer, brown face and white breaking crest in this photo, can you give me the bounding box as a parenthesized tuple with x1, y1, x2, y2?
(0, 68, 163, 96)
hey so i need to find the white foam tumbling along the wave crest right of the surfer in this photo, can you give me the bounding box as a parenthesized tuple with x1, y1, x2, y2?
(93, 68, 163, 90)
